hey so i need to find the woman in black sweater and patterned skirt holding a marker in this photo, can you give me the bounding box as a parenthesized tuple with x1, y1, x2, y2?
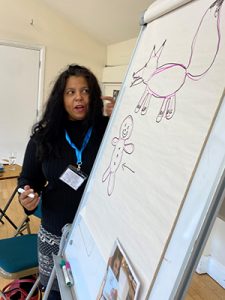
(19, 65, 113, 300)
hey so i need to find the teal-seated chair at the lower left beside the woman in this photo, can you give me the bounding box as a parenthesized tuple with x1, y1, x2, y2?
(0, 234, 39, 299)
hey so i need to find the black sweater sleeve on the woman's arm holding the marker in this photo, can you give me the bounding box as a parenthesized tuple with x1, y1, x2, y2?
(18, 138, 46, 215)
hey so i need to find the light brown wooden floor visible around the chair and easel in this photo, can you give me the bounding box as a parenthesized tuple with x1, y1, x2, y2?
(0, 179, 225, 300)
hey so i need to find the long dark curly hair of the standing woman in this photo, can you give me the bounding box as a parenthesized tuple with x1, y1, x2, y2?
(32, 64, 103, 159)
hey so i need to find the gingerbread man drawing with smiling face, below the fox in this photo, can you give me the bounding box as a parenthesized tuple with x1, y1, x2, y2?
(102, 115, 134, 196)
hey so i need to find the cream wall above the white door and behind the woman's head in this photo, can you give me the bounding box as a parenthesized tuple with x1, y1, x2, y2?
(0, 0, 107, 98)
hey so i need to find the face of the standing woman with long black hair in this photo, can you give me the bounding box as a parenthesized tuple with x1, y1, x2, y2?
(64, 76, 90, 121)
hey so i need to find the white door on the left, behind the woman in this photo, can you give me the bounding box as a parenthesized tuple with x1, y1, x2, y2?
(0, 42, 42, 165)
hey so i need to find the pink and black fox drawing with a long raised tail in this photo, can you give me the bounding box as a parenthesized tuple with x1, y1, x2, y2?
(131, 0, 224, 123)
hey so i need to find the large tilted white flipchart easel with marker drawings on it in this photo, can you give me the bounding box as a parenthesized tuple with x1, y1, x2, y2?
(43, 0, 225, 300)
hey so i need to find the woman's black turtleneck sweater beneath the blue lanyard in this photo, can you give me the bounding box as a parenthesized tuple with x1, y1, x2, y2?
(18, 117, 108, 235)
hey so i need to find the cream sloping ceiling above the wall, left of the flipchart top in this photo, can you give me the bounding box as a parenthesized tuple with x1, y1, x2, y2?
(43, 0, 154, 45)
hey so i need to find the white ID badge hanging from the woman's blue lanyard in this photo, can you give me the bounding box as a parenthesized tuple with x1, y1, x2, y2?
(59, 165, 87, 190)
